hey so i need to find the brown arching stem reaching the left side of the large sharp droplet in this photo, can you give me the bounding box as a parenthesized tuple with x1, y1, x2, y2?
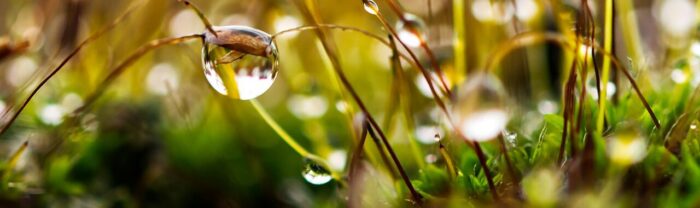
(76, 34, 202, 112)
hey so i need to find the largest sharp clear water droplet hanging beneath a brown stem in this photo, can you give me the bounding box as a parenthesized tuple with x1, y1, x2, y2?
(202, 26, 278, 100)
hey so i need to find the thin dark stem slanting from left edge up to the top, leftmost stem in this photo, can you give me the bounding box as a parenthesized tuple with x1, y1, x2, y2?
(0, 3, 141, 135)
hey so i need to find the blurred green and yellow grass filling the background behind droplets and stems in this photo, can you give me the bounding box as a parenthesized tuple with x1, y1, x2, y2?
(0, 0, 700, 207)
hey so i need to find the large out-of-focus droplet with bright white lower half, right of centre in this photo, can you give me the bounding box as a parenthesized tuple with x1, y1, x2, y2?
(452, 73, 509, 142)
